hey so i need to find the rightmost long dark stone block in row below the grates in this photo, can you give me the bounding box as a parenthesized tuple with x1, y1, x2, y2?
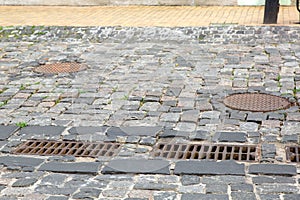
(249, 164, 297, 176)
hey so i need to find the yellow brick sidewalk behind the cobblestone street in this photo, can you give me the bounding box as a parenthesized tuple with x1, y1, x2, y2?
(0, 6, 299, 27)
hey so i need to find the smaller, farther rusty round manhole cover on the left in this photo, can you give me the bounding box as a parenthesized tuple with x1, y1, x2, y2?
(34, 62, 87, 74)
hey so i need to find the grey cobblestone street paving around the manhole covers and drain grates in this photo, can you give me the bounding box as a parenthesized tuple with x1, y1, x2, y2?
(0, 26, 300, 200)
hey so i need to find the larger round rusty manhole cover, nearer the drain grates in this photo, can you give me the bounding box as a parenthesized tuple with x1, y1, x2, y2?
(224, 93, 290, 112)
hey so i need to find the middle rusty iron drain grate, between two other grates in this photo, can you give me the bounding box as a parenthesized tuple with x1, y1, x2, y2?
(152, 143, 260, 162)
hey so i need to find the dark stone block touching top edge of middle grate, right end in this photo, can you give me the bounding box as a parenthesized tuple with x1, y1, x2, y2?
(213, 132, 247, 142)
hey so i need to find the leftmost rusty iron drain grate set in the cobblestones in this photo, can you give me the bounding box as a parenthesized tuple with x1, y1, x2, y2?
(13, 140, 121, 158)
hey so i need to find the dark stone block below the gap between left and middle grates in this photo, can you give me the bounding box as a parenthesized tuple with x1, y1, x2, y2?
(102, 159, 170, 174)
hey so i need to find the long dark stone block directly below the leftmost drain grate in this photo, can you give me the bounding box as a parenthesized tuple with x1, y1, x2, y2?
(38, 161, 102, 174)
